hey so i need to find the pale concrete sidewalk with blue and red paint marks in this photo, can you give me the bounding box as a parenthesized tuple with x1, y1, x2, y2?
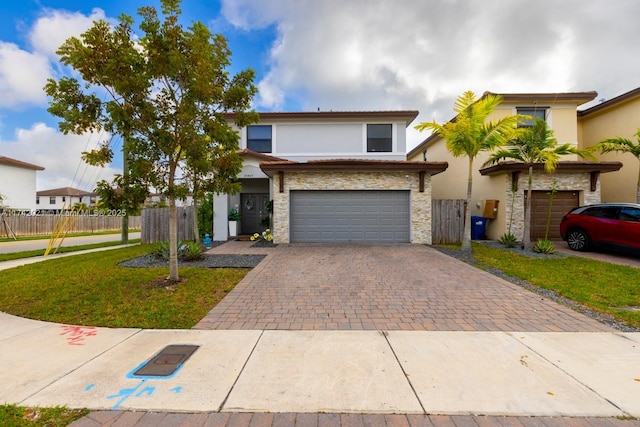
(0, 313, 640, 417)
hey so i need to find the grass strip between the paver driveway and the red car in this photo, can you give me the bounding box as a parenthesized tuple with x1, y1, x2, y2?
(473, 243, 640, 328)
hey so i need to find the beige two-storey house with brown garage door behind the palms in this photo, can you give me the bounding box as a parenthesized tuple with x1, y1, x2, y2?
(407, 92, 622, 240)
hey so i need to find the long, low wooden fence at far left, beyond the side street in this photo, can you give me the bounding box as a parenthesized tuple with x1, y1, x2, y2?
(0, 212, 140, 237)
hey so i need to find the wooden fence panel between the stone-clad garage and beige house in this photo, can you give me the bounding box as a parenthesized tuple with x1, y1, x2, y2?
(431, 199, 466, 244)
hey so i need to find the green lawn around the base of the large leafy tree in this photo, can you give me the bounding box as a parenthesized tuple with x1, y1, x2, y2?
(0, 245, 249, 329)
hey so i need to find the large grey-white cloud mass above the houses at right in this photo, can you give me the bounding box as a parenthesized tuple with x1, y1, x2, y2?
(222, 0, 640, 149)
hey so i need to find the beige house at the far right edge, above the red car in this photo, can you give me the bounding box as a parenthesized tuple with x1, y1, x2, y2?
(578, 88, 640, 203)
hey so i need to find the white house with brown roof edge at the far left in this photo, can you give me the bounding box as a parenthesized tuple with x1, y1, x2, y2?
(0, 156, 44, 211)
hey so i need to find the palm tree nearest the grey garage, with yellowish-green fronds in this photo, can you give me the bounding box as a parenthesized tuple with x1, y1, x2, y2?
(415, 91, 519, 251)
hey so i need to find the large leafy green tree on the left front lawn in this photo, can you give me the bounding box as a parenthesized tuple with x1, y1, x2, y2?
(45, 0, 257, 281)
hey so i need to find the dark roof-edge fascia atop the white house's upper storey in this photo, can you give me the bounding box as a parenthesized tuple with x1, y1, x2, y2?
(224, 110, 419, 127)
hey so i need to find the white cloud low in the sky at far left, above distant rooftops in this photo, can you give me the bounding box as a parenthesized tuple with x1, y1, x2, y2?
(0, 123, 121, 191)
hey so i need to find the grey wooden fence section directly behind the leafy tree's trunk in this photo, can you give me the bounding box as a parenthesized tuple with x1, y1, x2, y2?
(140, 206, 195, 243)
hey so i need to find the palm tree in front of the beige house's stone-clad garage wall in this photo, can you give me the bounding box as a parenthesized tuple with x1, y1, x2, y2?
(483, 119, 595, 249)
